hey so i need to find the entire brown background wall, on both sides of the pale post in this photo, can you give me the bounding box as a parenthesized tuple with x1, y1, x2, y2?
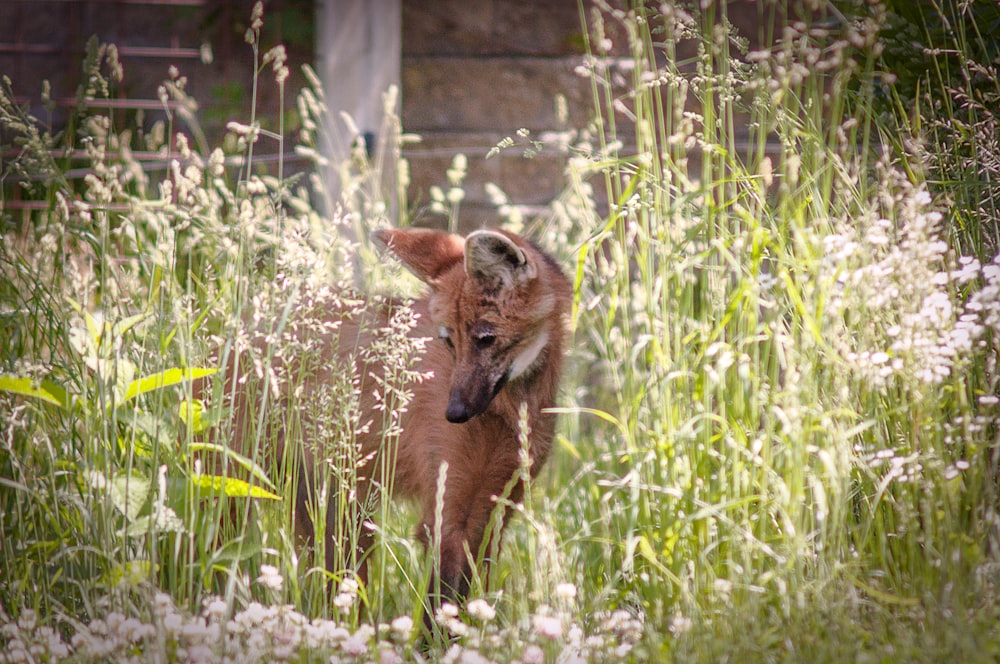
(0, 0, 772, 230)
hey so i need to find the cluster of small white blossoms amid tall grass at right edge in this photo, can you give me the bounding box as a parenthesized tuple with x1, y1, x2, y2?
(823, 184, 1000, 388)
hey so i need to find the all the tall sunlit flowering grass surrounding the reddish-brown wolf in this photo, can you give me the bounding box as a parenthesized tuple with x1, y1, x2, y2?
(0, 2, 1000, 662)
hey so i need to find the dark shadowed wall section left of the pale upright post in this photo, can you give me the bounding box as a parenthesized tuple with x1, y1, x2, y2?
(0, 0, 315, 145)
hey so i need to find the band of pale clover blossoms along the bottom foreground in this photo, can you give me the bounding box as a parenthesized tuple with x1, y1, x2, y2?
(0, 580, 644, 664)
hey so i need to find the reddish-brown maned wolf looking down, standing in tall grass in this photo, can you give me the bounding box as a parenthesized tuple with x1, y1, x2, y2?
(216, 229, 572, 624)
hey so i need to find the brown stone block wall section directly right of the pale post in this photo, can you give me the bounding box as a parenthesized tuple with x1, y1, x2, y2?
(402, 0, 590, 229)
